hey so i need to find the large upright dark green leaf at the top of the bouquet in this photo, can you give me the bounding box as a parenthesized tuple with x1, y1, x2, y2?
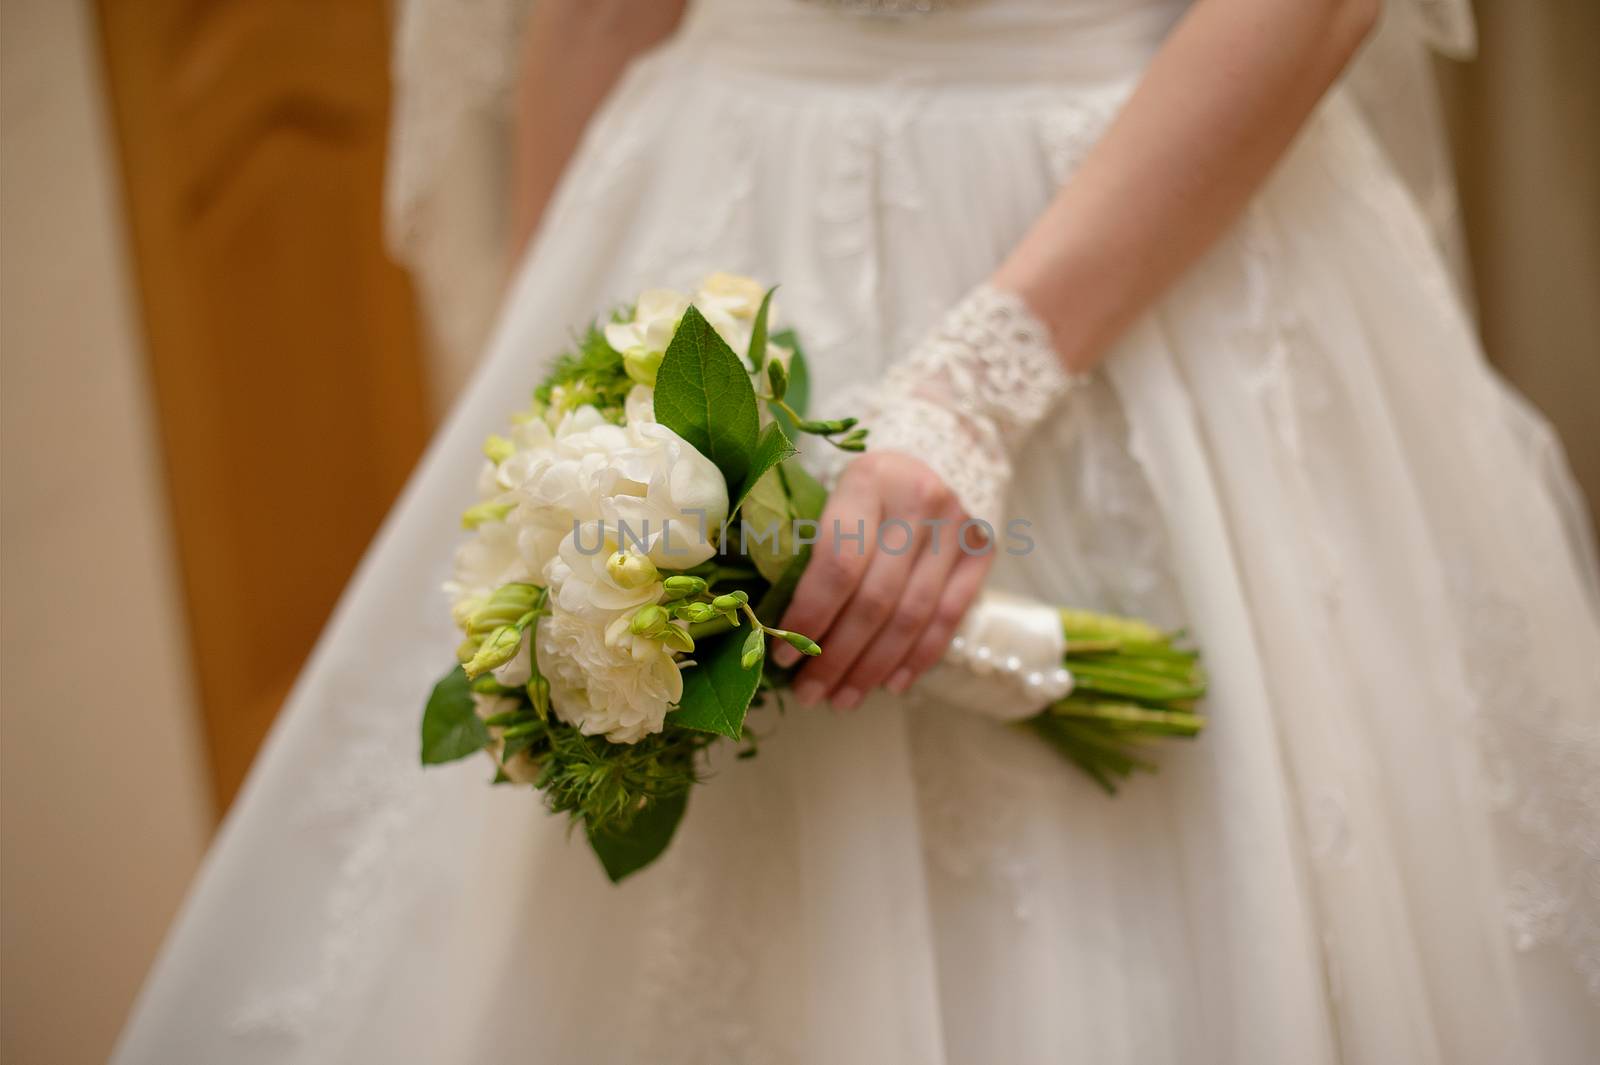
(654, 307, 760, 486)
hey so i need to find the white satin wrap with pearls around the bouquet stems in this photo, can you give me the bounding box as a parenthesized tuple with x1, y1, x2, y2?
(915, 592, 1072, 721)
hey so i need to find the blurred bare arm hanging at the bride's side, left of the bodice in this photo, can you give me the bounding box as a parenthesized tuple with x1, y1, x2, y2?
(512, 0, 685, 259)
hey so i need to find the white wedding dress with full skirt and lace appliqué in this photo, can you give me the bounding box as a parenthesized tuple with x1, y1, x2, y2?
(110, 0, 1600, 1065)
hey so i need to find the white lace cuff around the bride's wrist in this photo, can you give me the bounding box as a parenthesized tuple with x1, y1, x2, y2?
(867, 285, 1074, 529)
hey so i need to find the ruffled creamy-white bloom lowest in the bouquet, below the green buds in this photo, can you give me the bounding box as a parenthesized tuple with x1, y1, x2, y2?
(536, 604, 683, 744)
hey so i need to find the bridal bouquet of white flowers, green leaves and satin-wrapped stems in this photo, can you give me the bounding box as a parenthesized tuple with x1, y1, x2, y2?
(422, 273, 1205, 881)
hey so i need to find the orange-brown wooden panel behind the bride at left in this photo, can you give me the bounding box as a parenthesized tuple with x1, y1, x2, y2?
(98, 0, 426, 808)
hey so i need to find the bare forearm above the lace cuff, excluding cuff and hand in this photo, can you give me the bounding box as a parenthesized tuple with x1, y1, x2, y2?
(994, 0, 1381, 369)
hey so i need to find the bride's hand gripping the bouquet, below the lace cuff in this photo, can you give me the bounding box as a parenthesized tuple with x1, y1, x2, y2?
(774, 451, 994, 710)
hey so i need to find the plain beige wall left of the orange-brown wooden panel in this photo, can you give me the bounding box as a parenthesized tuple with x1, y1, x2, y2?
(0, 0, 211, 1065)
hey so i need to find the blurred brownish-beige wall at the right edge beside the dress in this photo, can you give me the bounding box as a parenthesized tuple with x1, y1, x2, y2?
(1442, 0, 1600, 518)
